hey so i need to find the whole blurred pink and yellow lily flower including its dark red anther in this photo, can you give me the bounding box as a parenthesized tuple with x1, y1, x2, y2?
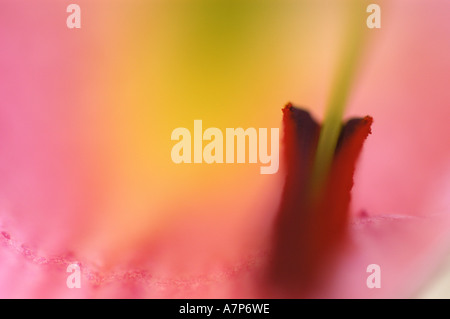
(0, 0, 450, 298)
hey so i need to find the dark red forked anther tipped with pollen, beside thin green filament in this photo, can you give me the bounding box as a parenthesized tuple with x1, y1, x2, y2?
(268, 104, 372, 296)
